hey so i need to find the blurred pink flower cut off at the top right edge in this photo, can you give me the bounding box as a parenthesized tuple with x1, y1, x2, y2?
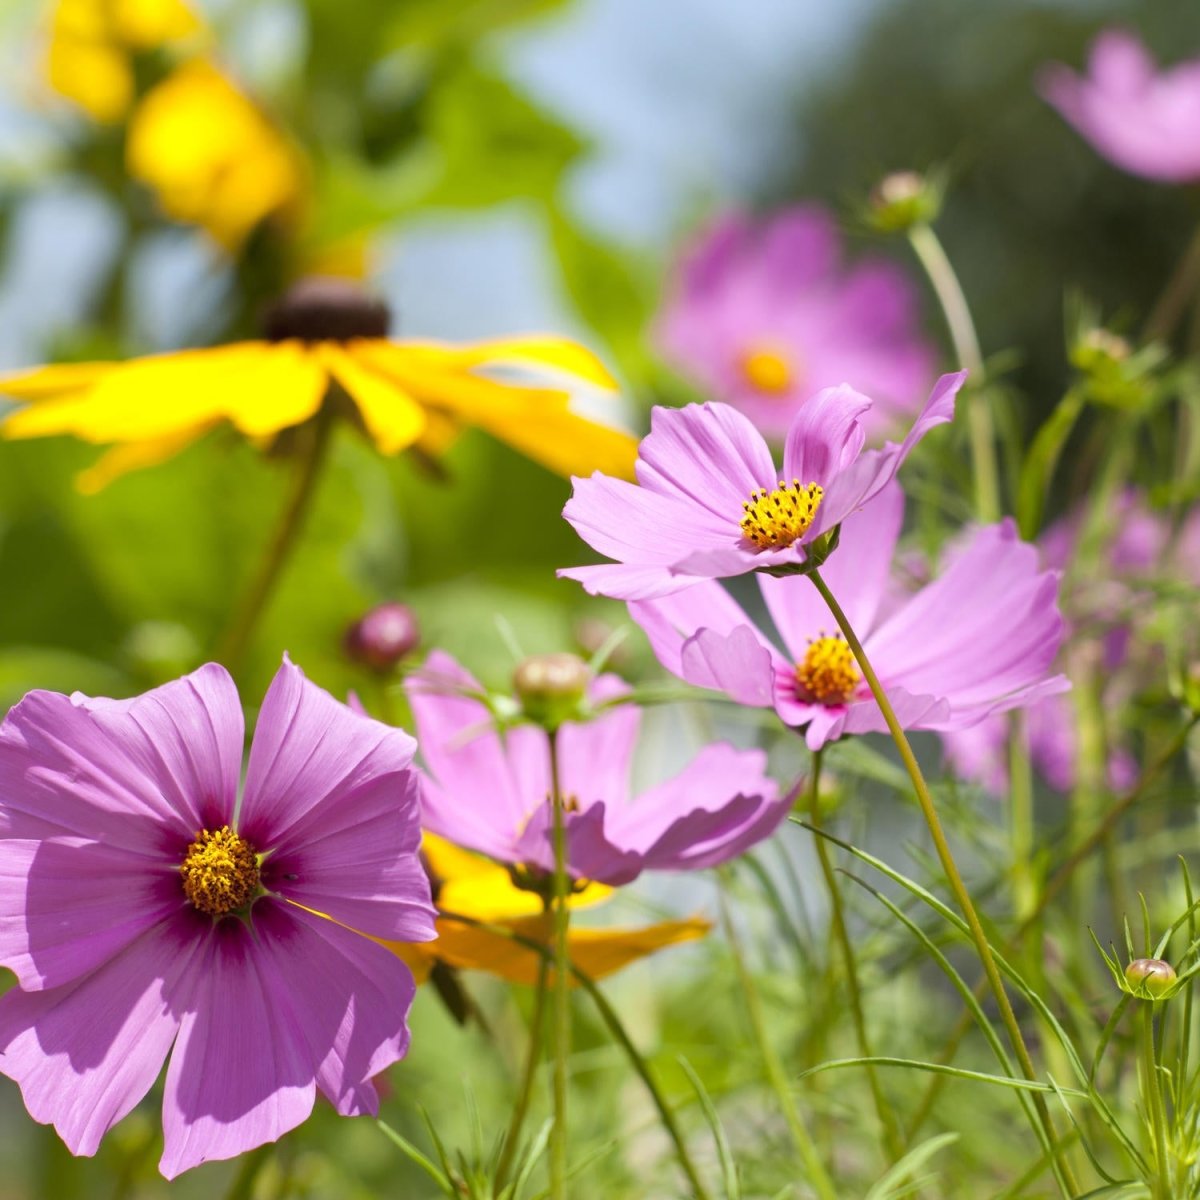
(1039, 30, 1200, 184)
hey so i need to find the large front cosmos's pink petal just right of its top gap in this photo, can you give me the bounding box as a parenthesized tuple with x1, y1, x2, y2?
(238, 656, 416, 851)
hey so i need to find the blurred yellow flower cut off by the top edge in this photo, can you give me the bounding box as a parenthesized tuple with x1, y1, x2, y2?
(46, 0, 202, 124)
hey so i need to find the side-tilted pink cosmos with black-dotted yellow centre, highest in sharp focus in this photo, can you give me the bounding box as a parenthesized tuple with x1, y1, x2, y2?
(558, 371, 966, 600)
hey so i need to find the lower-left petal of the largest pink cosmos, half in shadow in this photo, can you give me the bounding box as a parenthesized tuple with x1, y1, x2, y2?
(0, 913, 200, 1154)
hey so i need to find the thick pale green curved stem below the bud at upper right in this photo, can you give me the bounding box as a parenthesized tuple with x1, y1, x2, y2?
(908, 222, 1001, 522)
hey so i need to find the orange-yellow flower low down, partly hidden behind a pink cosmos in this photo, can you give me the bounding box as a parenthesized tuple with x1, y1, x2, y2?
(384, 834, 712, 985)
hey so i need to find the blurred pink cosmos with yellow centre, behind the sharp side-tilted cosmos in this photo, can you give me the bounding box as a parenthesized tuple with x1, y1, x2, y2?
(658, 205, 935, 437)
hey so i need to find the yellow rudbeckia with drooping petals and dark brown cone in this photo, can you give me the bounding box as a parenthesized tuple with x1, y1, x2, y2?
(0, 277, 636, 491)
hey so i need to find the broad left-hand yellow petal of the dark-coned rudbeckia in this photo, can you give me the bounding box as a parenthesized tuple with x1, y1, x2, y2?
(2, 342, 328, 443)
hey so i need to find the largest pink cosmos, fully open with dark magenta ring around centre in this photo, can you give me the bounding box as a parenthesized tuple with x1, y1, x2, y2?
(0, 660, 434, 1178)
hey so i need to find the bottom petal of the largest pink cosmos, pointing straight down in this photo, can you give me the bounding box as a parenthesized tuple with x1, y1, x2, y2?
(158, 900, 317, 1180)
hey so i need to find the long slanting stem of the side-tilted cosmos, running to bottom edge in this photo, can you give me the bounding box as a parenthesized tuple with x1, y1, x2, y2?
(809, 570, 1078, 1198)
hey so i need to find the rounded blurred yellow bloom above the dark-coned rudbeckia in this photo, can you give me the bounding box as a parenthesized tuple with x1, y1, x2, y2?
(125, 59, 306, 251)
